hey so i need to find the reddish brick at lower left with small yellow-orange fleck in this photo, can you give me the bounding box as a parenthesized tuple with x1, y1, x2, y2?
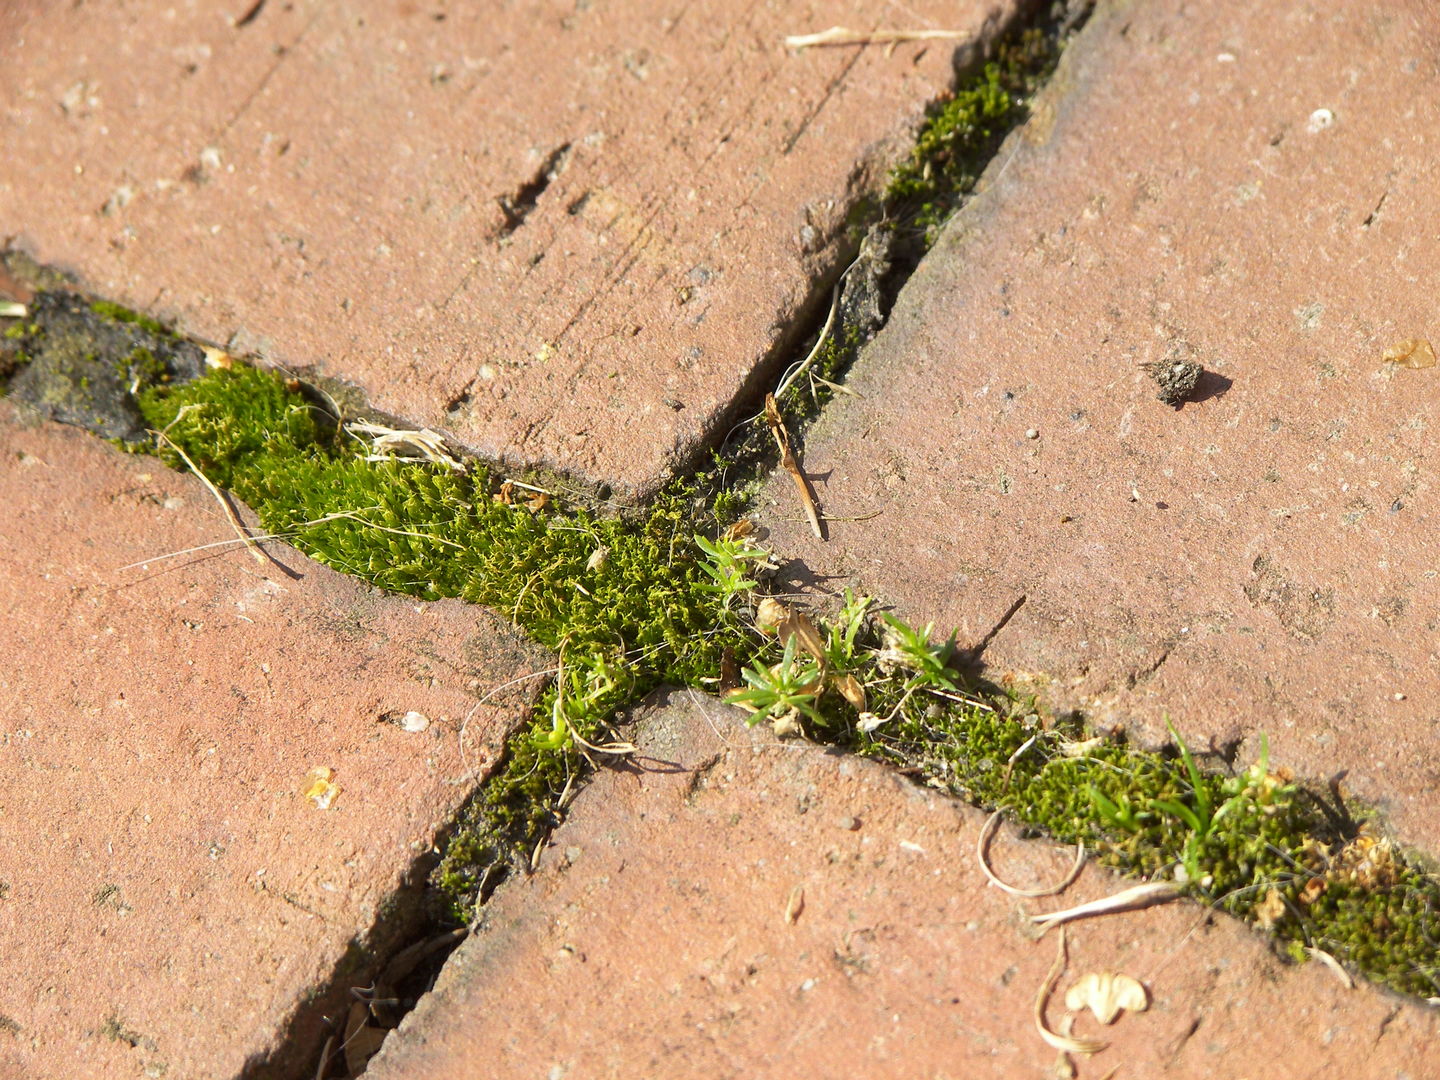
(0, 402, 544, 1080)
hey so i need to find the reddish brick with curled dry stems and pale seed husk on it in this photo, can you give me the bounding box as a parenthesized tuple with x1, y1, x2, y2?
(367, 693, 1440, 1080)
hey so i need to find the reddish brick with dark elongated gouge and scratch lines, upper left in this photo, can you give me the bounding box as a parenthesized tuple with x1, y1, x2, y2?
(0, 0, 1015, 492)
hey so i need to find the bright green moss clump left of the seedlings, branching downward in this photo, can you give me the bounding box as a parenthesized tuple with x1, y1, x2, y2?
(140, 366, 753, 909)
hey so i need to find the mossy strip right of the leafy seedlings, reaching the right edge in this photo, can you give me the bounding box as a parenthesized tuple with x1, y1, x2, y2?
(851, 698, 1440, 996)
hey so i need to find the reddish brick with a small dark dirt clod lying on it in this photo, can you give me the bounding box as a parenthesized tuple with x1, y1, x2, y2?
(768, 0, 1440, 851)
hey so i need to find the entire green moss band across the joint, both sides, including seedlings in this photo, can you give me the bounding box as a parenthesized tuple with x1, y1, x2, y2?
(120, 357, 1440, 995)
